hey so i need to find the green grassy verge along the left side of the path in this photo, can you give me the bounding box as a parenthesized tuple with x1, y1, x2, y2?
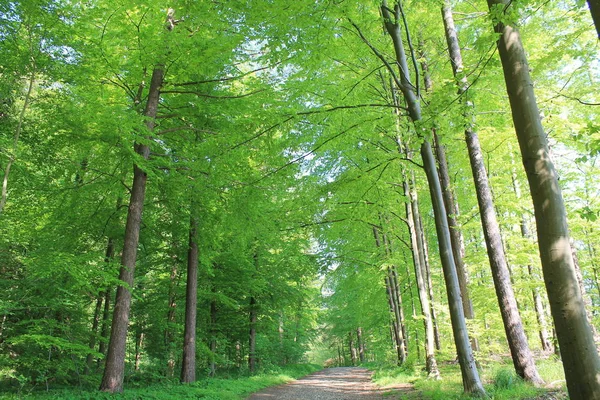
(0, 364, 322, 400)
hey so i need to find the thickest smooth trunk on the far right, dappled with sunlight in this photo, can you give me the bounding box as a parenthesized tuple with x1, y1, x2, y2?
(488, 0, 600, 400)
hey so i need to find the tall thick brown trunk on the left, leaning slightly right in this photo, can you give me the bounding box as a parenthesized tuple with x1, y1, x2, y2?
(100, 65, 164, 393)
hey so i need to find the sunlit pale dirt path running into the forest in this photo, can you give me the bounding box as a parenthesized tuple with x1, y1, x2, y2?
(247, 367, 412, 400)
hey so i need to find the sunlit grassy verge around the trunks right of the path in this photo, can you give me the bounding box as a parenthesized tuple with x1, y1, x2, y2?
(370, 358, 567, 400)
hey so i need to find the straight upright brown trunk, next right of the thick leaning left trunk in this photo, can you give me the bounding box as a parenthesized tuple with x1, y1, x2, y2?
(181, 214, 198, 383)
